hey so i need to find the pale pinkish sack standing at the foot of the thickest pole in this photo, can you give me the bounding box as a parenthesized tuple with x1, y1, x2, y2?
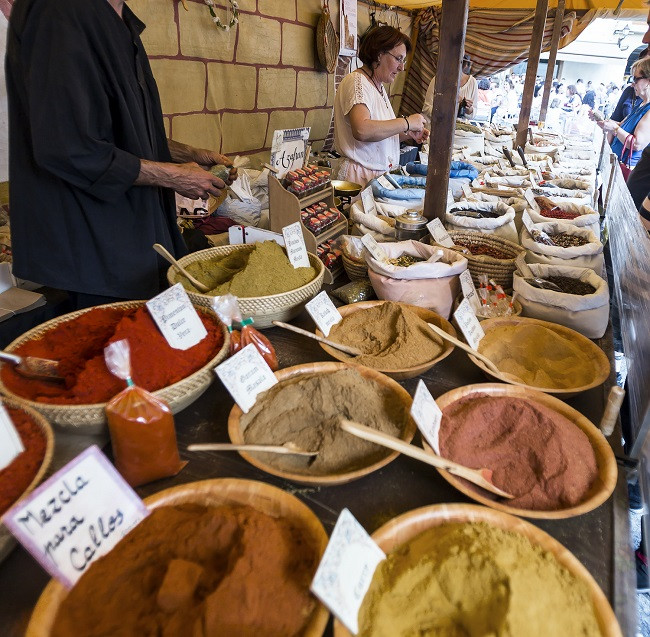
(366, 241, 467, 318)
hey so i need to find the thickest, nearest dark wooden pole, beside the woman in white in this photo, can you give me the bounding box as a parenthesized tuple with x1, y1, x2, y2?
(424, 0, 468, 221)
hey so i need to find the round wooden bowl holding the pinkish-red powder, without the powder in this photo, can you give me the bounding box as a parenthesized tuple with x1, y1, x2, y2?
(423, 383, 618, 520)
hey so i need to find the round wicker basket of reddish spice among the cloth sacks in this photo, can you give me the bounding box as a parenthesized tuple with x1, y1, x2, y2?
(449, 230, 525, 290)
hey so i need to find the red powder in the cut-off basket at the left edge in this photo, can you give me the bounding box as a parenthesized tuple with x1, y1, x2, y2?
(0, 407, 46, 515)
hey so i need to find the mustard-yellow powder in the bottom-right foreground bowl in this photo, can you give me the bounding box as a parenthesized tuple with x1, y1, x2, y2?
(358, 522, 601, 637)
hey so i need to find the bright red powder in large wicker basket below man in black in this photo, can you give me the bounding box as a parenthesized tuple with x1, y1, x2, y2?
(0, 307, 223, 405)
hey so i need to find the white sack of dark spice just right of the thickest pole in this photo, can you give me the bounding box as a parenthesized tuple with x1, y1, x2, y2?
(445, 201, 519, 243)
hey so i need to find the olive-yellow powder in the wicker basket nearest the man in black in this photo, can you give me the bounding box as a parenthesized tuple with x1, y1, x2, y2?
(177, 241, 316, 298)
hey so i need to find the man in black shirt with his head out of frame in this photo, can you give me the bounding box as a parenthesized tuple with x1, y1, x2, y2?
(5, 0, 234, 309)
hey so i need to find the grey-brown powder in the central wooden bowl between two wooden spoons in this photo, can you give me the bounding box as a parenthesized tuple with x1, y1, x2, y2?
(240, 368, 410, 476)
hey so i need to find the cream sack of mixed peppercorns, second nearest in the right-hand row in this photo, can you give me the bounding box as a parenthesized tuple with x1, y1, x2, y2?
(521, 221, 605, 274)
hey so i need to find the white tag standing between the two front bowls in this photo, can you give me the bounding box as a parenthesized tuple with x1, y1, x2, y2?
(310, 509, 386, 635)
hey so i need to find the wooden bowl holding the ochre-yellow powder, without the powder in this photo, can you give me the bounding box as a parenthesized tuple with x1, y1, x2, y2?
(468, 316, 610, 398)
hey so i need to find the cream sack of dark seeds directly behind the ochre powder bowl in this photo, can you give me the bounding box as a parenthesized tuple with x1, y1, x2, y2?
(513, 263, 609, 338)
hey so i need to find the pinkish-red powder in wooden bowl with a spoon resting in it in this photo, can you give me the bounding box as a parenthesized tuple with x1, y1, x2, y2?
(439, 394, 598, 511)
